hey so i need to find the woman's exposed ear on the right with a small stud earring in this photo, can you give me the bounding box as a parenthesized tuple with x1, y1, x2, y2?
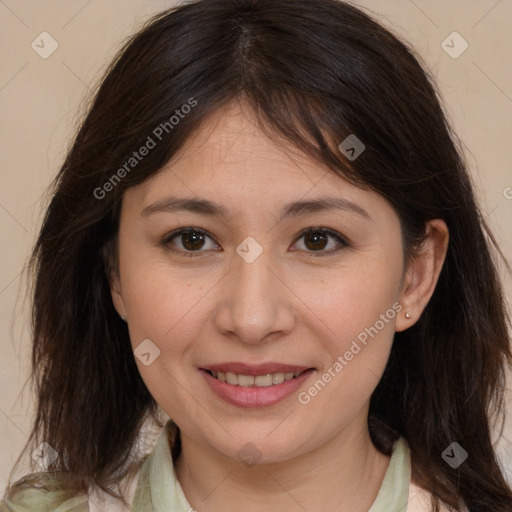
(395, 219, 449, 331)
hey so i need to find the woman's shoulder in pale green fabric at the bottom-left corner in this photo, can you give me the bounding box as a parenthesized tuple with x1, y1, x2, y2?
(0, 473, 89, 512)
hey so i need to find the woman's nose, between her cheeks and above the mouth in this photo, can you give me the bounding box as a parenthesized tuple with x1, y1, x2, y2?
(215, 247, 296, 344)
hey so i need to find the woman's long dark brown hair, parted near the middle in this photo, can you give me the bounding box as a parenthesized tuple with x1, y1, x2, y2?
(5, 0, 512, 512)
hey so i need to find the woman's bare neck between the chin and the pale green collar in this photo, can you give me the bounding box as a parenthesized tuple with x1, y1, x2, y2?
(175, 416, 389, 512)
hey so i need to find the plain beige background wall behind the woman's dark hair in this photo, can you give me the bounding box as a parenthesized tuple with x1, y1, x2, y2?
(0, 0, 512, 493)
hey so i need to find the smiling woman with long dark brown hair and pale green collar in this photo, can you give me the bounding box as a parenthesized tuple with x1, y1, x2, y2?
(0, 0, 512, 512)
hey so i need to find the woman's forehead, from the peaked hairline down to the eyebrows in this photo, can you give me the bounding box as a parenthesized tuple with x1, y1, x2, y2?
(126, 101, 396, 226)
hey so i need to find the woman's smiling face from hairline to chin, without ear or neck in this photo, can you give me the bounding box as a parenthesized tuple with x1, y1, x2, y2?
(112, 100, 416, 462)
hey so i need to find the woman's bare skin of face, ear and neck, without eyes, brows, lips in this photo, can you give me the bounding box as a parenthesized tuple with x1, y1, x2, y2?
(111, 102, 448, 512)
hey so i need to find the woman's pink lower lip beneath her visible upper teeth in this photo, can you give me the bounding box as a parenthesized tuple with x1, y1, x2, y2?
(200, 368, 315, 408)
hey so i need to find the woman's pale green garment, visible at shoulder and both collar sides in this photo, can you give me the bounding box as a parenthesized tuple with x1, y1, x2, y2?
(0, 422, 411, 512)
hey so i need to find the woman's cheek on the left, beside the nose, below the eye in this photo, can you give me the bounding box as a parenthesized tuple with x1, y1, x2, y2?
(125, 263, 208, 418)
